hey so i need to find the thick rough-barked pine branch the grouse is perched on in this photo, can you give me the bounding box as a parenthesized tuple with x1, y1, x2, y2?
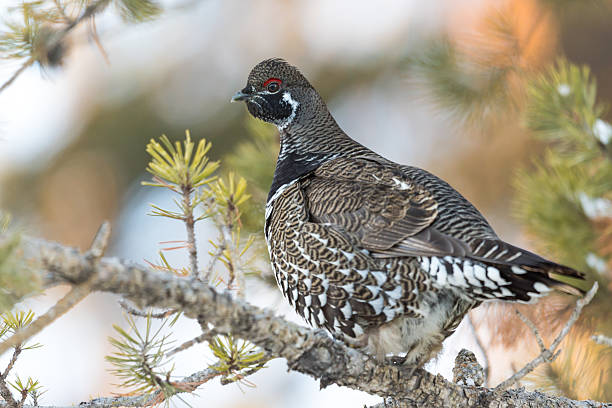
(0, 235, 612, 407)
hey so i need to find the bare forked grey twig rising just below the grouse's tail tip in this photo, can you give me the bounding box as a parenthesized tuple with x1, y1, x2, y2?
(493, 282, 598, 393)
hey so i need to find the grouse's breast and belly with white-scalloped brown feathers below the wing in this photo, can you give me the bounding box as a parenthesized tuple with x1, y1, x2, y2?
(265, 182, 432, 338)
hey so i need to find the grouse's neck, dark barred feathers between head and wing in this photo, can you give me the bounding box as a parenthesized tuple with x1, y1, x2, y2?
(268, 105, 371, 201)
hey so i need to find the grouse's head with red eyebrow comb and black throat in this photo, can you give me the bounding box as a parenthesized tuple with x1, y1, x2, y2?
(232, 58, 320, 129)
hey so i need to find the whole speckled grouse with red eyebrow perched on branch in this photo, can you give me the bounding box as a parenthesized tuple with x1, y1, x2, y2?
(231, 58, 584, 367)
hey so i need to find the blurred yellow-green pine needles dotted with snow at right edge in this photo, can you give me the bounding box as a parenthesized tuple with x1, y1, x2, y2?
(515, 60, 612, 270)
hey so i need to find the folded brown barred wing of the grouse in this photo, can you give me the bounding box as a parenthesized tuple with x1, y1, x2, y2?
(302, 158, 468, 256)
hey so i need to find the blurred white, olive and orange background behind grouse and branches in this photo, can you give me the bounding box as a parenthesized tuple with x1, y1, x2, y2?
(0, 0, 612, 407)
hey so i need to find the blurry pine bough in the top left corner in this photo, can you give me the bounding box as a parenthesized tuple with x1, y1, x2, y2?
(0, 0, 162, 92)
